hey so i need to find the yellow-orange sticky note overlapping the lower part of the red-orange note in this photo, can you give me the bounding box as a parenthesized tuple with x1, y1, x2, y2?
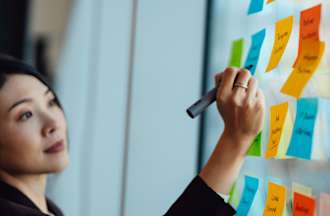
(281, 40, 325, 98)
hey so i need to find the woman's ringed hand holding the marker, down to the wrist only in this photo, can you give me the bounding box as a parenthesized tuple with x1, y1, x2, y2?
(215, 68, 265, 156)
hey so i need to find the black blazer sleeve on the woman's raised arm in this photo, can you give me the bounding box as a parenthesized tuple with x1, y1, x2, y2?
(165, 175, 236, 216)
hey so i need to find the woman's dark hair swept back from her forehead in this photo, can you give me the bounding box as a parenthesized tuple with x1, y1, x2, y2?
(0, 53, 63, 110)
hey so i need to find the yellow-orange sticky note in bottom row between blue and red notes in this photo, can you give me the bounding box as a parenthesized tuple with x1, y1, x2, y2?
(263, 182, 286, 216)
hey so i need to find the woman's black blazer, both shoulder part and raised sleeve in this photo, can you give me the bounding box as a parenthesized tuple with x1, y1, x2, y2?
(0, 176, 236, 216)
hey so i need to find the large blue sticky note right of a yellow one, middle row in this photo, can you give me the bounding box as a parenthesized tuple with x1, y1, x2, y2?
(287, 98, 319, 160)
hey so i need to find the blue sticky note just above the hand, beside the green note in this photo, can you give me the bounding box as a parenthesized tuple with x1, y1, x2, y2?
(244, 29, 266, 75)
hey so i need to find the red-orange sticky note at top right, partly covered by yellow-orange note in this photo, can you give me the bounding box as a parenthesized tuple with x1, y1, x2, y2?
(294, 4, 321, 66)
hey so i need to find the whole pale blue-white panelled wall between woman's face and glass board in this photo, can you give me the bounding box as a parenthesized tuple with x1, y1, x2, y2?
(48, 0, 205, 216)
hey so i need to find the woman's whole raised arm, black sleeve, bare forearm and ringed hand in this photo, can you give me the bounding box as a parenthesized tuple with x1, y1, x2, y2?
(166, 68, 265, 216)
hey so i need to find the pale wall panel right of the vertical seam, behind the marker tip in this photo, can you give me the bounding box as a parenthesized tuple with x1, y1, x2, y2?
(124, 0, 205, 216)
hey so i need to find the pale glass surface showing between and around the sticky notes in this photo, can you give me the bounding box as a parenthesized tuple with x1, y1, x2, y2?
(202, 0, 330, 215)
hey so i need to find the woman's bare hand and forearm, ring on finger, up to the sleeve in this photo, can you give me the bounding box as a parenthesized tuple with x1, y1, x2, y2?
(199, 68, 265, 194)
